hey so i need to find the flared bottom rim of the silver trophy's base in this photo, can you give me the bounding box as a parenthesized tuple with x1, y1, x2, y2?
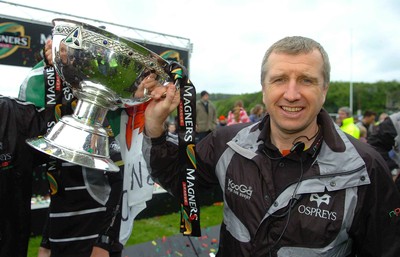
(26, 137, 119, 172)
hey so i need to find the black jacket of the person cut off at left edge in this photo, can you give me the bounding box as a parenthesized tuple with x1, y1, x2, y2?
(0, 95, 45, 257)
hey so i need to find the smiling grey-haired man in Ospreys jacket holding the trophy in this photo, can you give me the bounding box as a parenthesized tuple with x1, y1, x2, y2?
(143, 36, 400, 257)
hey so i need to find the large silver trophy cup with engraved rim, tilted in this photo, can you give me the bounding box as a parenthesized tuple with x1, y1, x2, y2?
(27, 19, 170, 172)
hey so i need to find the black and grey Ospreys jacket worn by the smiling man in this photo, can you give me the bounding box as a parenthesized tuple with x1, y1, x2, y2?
(143, 110, 400, 257)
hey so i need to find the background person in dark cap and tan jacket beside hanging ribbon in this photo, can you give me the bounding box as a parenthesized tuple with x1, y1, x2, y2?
(196, 91, 217, 142)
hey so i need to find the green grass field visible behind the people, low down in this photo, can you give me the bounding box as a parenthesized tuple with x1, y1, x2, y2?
(28, 203, 223, 254)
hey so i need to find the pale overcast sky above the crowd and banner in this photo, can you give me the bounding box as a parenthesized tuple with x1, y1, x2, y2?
(0, 0, 400, 96)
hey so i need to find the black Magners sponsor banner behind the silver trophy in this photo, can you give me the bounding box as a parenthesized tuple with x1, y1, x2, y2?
(0, 17, 189, 67)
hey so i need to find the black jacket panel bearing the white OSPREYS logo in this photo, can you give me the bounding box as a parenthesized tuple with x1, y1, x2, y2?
(254, 187, 346, 251)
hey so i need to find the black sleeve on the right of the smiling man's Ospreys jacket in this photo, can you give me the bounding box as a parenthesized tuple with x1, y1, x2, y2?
(349, 143, 400, 257)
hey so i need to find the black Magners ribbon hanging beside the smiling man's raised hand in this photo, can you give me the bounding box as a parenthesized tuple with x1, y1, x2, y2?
(169, 62, 201, 236)
